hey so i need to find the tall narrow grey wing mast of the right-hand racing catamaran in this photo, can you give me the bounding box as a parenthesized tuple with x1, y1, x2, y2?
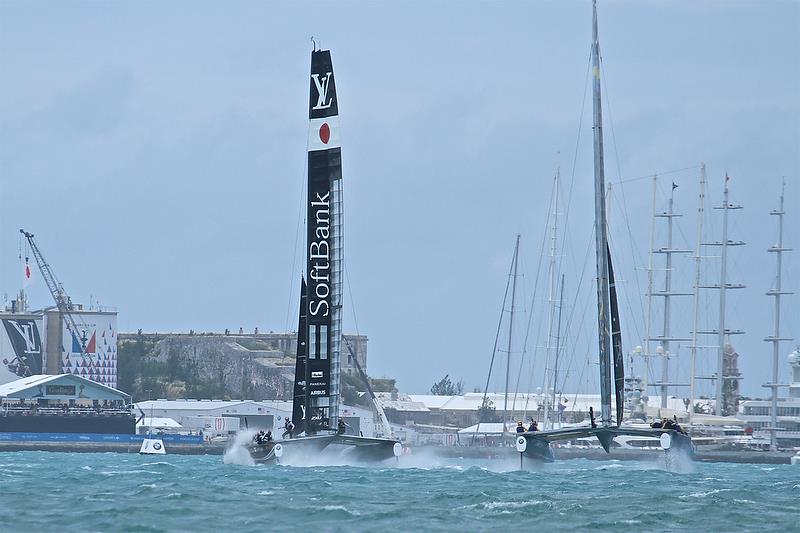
(592, 0, 619, 426)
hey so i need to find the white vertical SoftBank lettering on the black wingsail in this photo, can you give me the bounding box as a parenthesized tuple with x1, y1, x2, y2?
(308, 191, 331, 317)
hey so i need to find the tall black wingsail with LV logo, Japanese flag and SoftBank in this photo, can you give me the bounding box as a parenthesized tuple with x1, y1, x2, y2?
(305, 50, 342, 433)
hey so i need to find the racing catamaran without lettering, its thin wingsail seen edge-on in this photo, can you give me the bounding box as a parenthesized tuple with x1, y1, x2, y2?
(517, 0, 694, 461)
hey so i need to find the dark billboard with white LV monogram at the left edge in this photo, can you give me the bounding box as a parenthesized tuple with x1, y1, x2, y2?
(0, 315, 43, 385)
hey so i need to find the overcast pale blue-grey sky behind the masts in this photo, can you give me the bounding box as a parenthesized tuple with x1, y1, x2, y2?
(0, 1, 800, 395)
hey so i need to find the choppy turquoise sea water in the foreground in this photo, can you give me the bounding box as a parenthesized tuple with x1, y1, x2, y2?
(0, 452, 800, 532)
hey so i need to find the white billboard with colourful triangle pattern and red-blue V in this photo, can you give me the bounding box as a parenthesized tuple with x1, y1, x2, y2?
(61, 311, 117, 388)
